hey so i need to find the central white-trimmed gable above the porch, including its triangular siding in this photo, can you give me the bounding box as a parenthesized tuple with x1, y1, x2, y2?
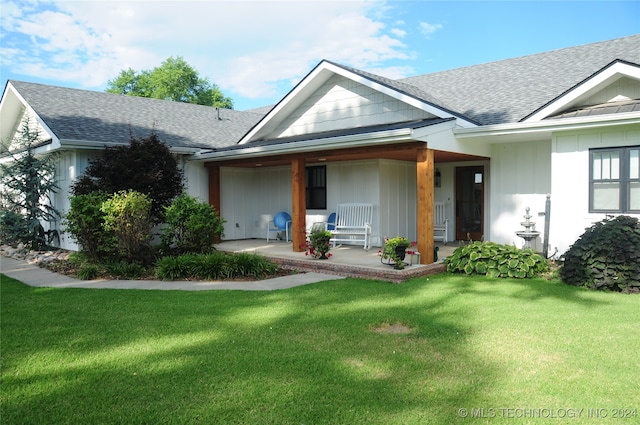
(240, 61, 475, 144)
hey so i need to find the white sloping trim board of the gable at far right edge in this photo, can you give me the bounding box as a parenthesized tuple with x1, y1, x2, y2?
(522, 61, 640, 123)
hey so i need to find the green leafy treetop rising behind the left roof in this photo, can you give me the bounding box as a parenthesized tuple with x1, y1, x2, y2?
(106, 56, 233, 109)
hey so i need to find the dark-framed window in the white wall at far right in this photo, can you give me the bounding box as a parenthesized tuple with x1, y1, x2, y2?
(589, 146, 640, 213)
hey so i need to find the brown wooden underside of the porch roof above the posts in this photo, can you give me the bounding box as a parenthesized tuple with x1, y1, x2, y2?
(207, 142, 486, 168)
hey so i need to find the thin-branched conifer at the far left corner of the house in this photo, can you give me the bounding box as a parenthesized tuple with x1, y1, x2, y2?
(0, 119, 59, 250)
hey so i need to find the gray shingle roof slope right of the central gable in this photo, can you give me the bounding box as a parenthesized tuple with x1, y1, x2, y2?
(400, 35, 640, 125)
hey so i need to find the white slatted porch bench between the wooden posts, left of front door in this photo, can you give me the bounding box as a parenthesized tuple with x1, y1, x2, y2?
(325, 204, 373, 250)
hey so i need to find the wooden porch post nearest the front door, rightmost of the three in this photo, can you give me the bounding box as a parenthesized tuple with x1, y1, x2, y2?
(416, 145, 434, 264)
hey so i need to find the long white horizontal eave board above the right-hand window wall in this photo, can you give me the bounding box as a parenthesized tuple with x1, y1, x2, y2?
(453, 112, 640, 142)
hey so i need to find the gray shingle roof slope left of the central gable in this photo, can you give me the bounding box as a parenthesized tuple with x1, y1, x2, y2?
(11, 80, 262, 148)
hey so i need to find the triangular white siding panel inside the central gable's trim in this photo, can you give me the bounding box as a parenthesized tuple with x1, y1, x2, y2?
(268, 75, 434, 138)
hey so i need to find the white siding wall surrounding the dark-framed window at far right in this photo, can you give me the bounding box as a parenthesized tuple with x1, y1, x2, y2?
(549, 125, 640, 254)
